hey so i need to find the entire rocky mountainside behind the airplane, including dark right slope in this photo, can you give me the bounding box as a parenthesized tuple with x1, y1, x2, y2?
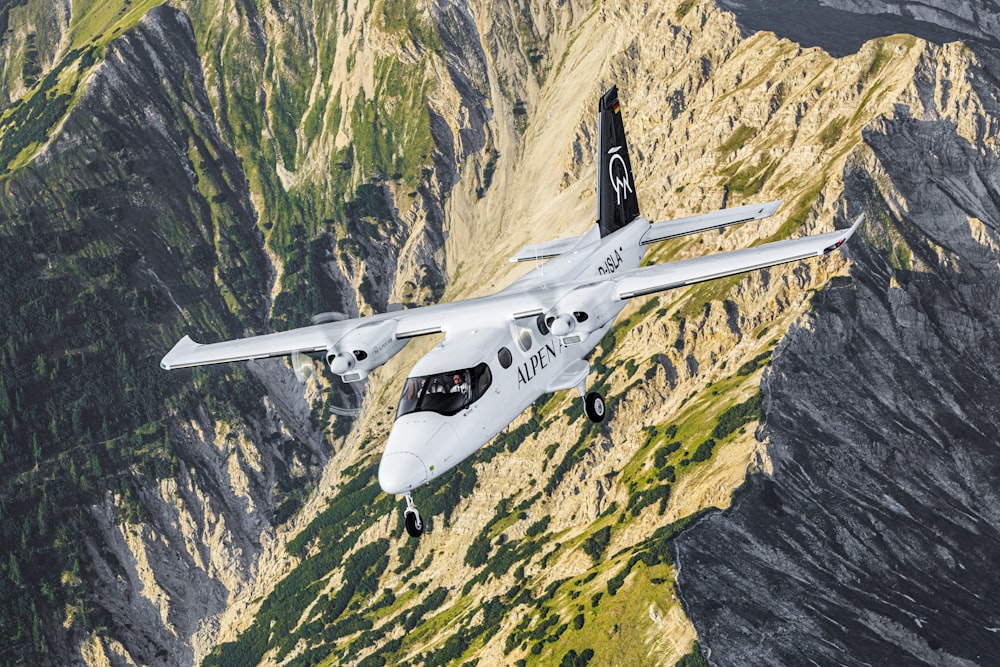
(0, 0, 1000, 665)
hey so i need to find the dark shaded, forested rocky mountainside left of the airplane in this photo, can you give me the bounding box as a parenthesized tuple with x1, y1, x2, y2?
(3, 8, 328, 663)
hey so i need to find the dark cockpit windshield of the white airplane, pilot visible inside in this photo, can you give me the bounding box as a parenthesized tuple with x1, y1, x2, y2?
(396, 364, 493, 419)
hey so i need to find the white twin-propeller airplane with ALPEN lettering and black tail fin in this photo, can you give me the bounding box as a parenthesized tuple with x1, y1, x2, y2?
(160, 88, 863, 537)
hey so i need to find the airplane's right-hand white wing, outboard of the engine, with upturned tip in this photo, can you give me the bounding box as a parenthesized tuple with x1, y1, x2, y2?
(615, 214, 865, 299)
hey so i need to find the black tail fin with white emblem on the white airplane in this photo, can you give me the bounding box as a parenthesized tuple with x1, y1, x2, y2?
(597, 86, 639, 236)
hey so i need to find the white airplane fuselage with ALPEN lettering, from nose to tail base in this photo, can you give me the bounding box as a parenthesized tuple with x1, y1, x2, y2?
(378, 218, 649, 494)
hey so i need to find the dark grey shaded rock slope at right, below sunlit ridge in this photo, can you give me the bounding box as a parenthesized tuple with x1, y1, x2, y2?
(675, 27, 1000, 665)
